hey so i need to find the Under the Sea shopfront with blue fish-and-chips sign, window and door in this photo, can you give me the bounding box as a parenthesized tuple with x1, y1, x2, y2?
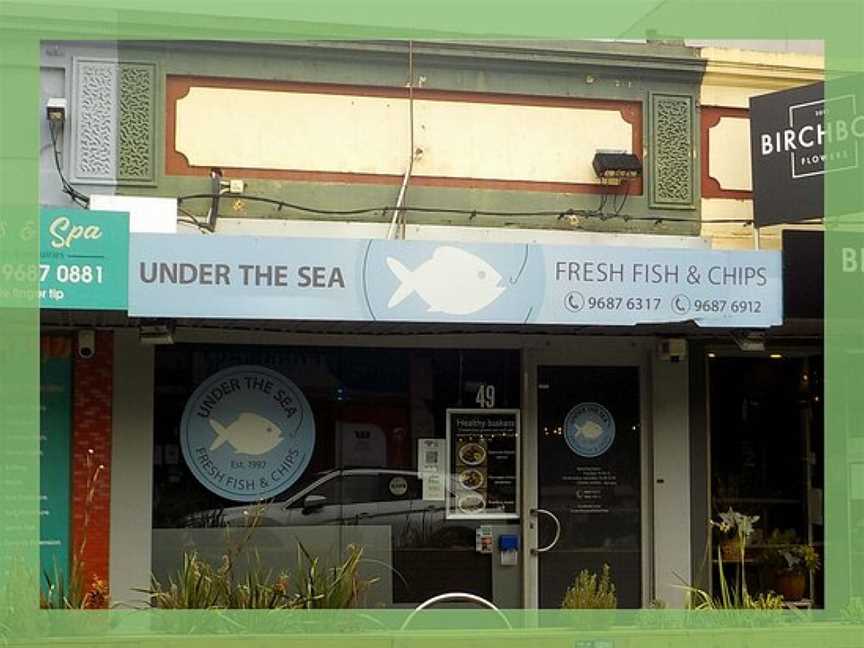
(37, 210, 796, 608)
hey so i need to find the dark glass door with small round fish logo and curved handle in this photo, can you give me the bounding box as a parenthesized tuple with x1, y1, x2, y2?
(534, 364, 643, 608)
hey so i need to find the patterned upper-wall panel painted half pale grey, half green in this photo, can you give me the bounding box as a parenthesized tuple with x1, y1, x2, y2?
(71, 59, 156, 184)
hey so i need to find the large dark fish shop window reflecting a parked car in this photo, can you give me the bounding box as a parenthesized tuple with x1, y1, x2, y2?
(153, 345, 520, 607)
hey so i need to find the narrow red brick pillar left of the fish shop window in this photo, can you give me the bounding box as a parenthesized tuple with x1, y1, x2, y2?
(72, 331, 114, 604)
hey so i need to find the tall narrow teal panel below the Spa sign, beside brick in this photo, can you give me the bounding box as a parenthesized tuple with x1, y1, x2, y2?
(39, 336, 72, 588)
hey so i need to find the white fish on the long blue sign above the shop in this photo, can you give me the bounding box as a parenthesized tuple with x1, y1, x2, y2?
(387, 246, 505, 315)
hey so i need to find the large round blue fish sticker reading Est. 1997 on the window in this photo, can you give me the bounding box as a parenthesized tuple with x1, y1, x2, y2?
(180, 366, 315, 502)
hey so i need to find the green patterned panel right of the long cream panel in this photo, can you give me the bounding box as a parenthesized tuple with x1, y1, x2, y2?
(649, 94, 696, 209)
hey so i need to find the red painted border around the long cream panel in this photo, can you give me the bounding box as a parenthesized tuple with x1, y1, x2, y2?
(165, 75, 643, 195)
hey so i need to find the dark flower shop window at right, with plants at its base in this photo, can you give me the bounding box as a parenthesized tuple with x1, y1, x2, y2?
(706, 355, 824, 606)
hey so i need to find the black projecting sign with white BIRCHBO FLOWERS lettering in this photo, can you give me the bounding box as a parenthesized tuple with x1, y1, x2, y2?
(750, 76, 864, 227)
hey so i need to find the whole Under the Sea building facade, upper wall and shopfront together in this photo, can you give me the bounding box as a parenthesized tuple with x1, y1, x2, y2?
(37, 39, 821, 608)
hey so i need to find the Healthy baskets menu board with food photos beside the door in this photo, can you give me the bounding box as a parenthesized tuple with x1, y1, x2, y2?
(446, 409, 519, 520)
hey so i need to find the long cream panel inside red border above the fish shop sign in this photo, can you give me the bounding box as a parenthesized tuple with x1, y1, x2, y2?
(175, 87, 633, 183)
